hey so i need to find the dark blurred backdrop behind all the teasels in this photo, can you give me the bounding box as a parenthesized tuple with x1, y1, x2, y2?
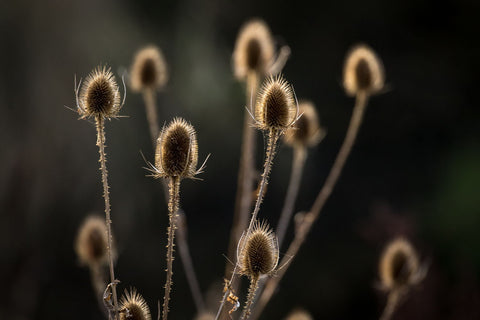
(0, 0, 480, 319)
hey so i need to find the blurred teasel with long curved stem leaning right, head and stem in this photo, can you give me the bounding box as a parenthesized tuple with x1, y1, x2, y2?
(251, 44, 384, 319)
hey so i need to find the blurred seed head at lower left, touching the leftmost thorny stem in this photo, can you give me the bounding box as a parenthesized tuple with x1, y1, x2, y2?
(75, 215, 112, 267)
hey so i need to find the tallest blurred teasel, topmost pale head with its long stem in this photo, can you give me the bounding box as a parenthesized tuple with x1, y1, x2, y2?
(225, 19, 290, 287)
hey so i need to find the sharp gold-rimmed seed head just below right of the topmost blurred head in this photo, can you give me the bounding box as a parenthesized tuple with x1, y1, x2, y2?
(255, 76, 297, 130)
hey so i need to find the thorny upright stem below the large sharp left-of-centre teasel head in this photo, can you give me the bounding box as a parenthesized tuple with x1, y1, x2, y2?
(162, 177, 180, 320)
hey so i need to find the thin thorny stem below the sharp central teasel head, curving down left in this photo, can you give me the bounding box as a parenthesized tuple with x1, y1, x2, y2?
(215, 129, 283, 320)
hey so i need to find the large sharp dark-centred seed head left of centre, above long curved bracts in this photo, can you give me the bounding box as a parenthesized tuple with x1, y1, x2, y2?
(155, 118, 198, 178)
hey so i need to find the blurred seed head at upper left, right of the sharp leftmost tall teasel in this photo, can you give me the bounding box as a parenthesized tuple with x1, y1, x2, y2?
(130, 46, 168, 91)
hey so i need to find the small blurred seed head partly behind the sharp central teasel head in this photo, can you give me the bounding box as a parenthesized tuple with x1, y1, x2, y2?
(285, 101, 325, 147)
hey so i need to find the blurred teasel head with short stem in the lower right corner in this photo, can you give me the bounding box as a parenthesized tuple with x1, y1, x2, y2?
(378, 237, 428, 320)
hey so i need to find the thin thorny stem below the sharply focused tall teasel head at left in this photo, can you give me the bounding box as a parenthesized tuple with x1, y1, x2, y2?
(95, 115, 119, 319)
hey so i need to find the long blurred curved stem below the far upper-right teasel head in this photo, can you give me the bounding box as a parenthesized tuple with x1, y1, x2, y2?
(252, 92, 368, 319)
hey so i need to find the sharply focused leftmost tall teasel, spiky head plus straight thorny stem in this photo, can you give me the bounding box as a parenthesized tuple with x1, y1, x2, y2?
(74, 66, 126, 319)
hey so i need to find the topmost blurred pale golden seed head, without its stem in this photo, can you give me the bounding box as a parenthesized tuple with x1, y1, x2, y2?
(233, 19, 275, 80)
